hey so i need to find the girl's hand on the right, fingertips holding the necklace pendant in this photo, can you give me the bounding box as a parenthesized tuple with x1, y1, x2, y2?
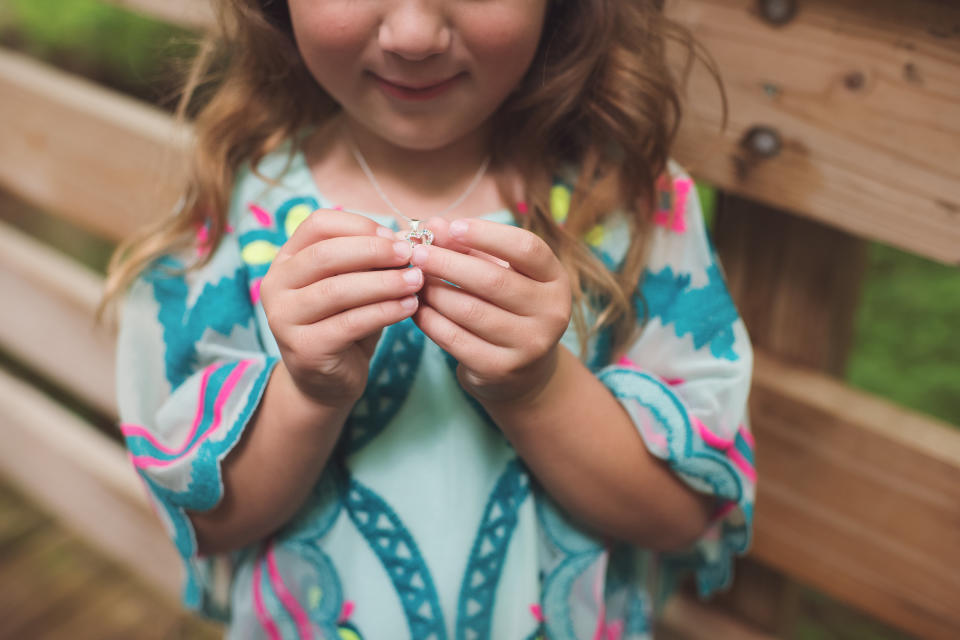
(411, 218, 571, 403)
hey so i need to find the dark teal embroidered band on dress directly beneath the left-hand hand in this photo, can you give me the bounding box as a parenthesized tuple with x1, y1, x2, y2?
(341, 318, 425, 454)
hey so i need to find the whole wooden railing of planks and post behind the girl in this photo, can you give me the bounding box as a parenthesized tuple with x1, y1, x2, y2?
(0, 0, 960, 638)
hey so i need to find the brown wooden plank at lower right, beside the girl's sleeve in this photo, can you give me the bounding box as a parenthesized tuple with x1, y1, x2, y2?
(751, 353, 960, 638)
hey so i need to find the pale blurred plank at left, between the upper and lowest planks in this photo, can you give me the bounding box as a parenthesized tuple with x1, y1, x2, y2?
(0, 223, 117, 416)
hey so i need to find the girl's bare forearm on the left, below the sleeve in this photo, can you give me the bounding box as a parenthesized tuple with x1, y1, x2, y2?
(190, 362, 350, 554)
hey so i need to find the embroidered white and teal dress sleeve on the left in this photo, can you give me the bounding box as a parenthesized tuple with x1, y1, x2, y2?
(117, 236, 275, 617)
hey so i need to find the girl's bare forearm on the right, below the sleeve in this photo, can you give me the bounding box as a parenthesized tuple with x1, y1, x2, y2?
(484, 347, 712, 549)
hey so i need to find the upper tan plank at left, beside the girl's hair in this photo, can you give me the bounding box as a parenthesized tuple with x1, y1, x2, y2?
(0, 50, 189, 239)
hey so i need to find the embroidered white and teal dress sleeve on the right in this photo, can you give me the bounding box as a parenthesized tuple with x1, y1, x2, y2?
(598, 170, 757, 596)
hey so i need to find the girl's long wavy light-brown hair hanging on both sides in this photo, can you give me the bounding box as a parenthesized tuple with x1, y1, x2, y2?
(104, 0, 726, 356)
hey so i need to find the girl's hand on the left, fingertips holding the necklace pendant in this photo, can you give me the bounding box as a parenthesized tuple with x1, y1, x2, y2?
(260, 209, 423, 407)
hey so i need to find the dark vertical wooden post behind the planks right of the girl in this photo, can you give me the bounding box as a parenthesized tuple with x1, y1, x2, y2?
(714, 194, 867, 635)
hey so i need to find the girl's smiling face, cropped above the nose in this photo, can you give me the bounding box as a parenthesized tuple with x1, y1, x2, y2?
(289, 0, 547, 150)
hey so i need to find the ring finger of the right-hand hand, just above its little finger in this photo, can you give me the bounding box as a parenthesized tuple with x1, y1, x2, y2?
(420, 278, 525, 347)
